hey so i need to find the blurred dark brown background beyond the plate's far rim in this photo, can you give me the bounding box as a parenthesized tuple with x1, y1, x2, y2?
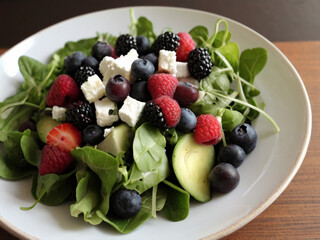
(0, 0, 320, 48)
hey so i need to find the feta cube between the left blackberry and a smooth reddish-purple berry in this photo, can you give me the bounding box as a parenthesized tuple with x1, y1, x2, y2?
(80, 74, 106, 103)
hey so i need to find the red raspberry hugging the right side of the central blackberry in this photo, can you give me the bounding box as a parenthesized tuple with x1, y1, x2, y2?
(153, 96, 181, 128)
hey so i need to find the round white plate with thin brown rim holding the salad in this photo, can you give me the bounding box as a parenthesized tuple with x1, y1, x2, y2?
(0, 7, 311, 240)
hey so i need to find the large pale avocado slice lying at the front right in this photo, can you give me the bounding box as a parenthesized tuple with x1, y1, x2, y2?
(172, 133, 214, 202)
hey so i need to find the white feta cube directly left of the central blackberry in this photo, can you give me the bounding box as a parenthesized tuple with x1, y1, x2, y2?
(119, 96, 146, 127)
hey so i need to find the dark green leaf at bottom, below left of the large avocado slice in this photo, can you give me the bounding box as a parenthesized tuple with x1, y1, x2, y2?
(161, 180, 190, 221)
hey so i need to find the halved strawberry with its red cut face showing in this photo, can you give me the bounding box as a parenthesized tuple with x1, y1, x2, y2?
(47, 123, 81, 152)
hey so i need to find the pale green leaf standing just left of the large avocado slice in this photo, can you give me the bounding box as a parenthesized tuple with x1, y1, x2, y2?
(124, 122, 170, 194)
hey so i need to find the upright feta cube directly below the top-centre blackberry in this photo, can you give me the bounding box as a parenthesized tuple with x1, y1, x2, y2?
(158, 50, 177, 76)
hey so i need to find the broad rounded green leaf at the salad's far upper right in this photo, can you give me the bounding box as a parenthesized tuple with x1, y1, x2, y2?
(239, 48, 268, 84)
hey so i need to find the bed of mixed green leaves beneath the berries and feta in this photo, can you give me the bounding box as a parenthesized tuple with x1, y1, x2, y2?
(0, 9, 279, 233)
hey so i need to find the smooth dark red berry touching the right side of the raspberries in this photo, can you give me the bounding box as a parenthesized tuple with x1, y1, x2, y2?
(173, 82, 199, 107)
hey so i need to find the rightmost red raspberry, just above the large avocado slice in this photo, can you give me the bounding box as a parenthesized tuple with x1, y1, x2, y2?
(194, 114, 222, 145)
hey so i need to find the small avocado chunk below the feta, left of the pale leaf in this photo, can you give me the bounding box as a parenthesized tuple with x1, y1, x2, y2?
(97, 123, 133, 156)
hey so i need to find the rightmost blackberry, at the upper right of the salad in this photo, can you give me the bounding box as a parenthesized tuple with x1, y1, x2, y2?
(188, 48, 212, 79)
